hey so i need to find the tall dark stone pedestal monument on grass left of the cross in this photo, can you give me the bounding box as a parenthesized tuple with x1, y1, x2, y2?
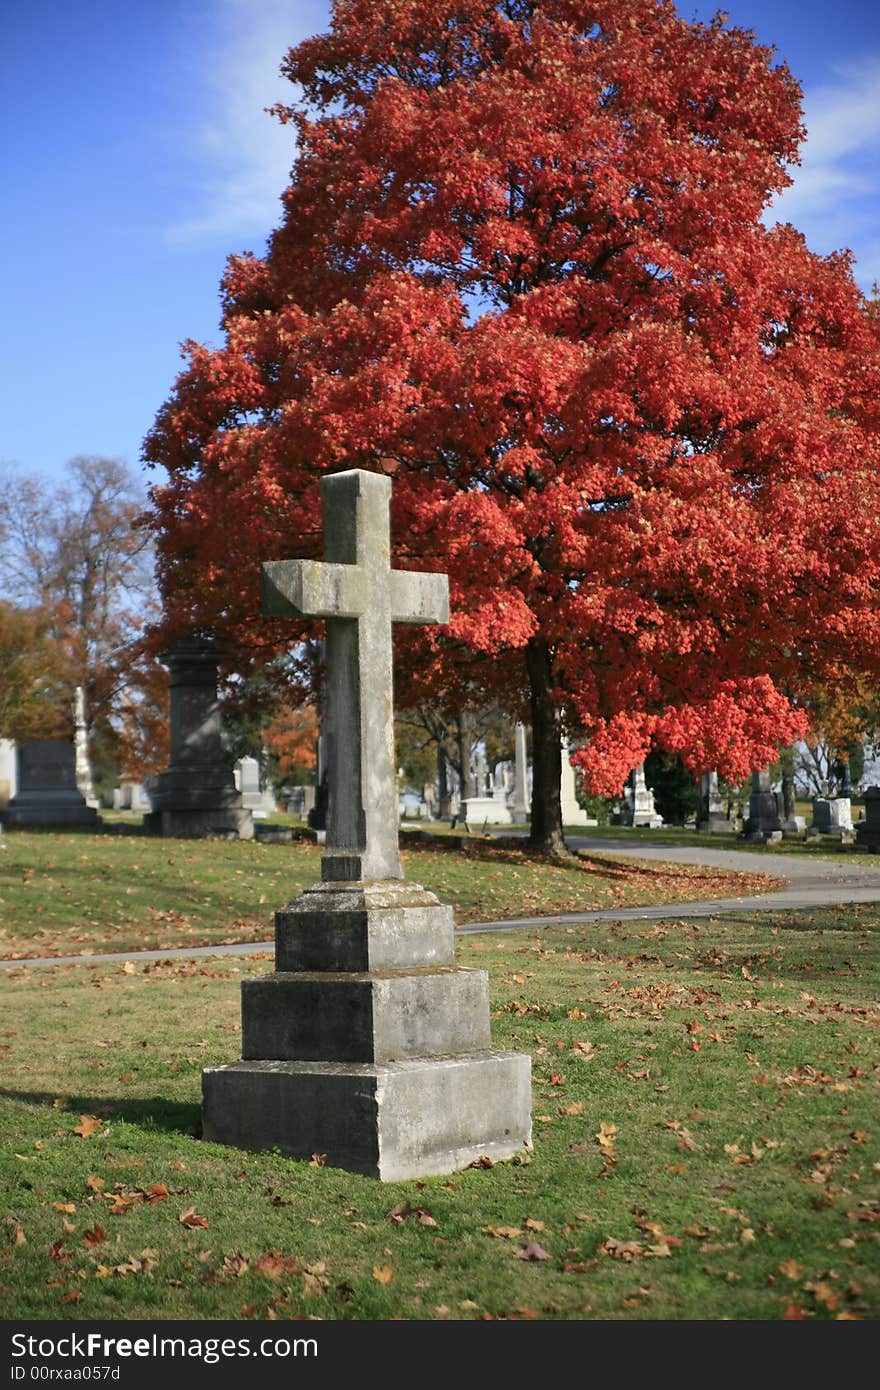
(143, 638, 253, 840)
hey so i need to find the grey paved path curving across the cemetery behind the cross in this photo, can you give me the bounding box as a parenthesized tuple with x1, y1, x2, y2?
(0, 835, 880, 969)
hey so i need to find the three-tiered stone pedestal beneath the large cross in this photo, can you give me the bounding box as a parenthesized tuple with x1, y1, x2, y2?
(203, 880, 531, 1182)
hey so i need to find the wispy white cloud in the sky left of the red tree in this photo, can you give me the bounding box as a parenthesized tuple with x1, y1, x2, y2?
(167, 0, 328, 243)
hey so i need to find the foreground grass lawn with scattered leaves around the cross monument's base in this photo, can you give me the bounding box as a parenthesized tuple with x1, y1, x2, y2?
(0, 906, 880, 1321)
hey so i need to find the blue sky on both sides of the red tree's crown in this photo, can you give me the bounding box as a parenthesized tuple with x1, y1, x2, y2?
(0, 0, 880, 492)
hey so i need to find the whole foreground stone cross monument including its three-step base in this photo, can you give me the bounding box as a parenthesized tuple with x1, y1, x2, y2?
(203, 470, 531, 1180)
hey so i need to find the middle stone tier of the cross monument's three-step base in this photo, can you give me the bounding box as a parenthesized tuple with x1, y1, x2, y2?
(242, 966, 492, 1062)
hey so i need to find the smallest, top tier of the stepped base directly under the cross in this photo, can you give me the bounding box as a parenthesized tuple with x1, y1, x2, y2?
(275, 878, 455, 970)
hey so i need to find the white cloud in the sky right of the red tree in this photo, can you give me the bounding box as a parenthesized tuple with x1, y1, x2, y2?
(767, 56, 880, 289)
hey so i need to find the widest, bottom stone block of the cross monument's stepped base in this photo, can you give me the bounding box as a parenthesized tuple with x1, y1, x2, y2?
(202, 1051, 531, 1182)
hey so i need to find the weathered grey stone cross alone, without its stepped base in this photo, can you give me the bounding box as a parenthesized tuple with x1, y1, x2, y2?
(263, 468, 449, 881)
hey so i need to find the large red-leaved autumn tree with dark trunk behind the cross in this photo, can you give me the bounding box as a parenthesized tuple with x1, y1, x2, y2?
(145, 0, 880, 848)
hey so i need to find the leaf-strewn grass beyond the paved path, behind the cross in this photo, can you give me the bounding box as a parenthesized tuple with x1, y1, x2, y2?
(0, 828, 776, 958)
